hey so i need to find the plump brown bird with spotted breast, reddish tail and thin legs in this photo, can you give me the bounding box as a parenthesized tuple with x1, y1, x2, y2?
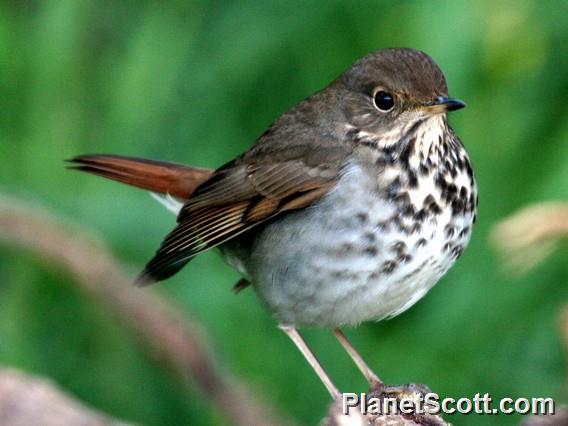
(68, 48, 478, 398)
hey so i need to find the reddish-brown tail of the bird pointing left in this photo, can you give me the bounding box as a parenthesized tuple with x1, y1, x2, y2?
(68, 154, 213, 200)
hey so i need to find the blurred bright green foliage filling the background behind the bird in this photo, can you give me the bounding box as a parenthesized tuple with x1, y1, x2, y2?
(0, 0, 568, 425)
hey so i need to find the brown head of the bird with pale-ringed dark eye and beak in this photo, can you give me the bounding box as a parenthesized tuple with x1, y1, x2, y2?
(334, 48, 465, 146)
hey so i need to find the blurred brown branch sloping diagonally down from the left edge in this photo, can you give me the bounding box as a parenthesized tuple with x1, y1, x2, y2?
(0, 196, 289, 426)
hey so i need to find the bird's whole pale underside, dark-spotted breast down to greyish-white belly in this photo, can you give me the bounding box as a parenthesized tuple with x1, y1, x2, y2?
(221, 116, 477, 327)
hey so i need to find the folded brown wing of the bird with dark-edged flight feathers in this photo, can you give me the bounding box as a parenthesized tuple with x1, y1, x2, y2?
(138, 159, 341, 285)
